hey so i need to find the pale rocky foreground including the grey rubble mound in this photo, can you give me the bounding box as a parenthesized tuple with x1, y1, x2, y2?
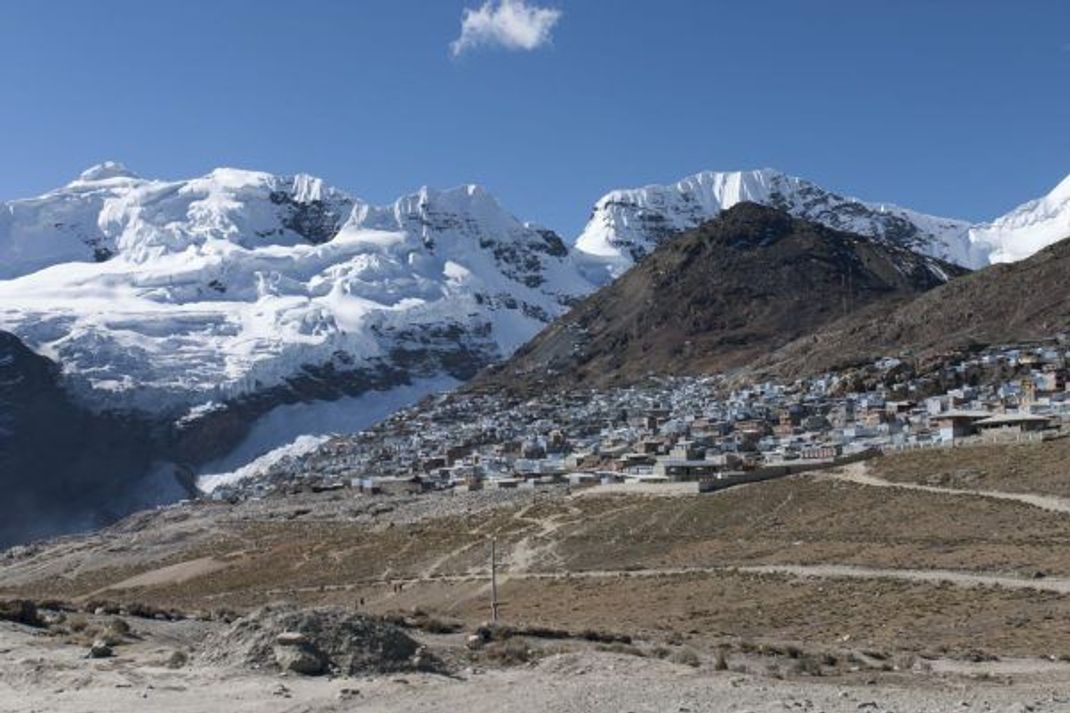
(0, 610, 1070, 713)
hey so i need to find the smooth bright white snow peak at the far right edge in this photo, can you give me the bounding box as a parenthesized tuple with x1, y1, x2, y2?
(969, 176, 1070, 263)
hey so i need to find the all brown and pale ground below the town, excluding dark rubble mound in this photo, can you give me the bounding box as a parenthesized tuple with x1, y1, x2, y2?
(10, 442, 1070, 713)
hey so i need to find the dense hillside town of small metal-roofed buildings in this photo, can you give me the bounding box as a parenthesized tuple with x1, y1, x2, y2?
(212, 337, 1070, 501)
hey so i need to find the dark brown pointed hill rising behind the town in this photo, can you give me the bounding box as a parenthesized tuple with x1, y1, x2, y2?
(485, 202, 965, 385)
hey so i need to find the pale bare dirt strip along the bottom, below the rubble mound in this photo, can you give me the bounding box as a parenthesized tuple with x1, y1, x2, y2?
(0, 622, 1068, 713)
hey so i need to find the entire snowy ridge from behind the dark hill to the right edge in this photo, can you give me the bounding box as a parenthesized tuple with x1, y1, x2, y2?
(576, 169, 1070, 283)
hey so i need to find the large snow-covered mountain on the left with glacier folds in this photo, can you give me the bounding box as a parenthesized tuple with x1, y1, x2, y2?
(0, 164, 590, 412)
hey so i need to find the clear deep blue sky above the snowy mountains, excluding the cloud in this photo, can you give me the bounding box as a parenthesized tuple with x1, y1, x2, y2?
(0, 0, 1070, 237)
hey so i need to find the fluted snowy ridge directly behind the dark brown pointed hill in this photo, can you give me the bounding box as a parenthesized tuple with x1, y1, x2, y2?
(576, 169, 987, 282)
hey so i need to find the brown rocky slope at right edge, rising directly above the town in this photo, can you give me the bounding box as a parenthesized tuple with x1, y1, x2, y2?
(756, 230, 1070, 376)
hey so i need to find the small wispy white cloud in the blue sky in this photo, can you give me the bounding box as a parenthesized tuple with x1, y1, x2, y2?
(449, 0, 561, 57)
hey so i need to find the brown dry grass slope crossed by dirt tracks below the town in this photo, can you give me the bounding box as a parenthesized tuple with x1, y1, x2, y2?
(6, 441, 1070, 659)
